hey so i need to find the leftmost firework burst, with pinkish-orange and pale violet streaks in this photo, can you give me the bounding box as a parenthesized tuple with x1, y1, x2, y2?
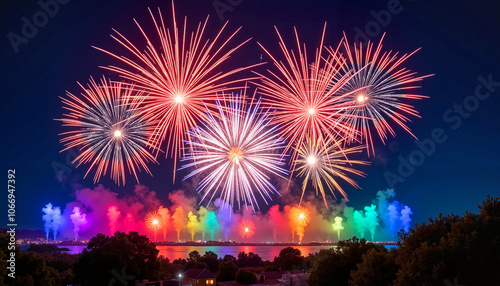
(56, 77, 156, 185)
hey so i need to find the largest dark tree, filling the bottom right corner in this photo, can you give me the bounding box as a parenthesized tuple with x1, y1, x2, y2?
(394, 196, 500, 285)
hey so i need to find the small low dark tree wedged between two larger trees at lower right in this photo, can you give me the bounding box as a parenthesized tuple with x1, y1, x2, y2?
(349, 249, 398, 286)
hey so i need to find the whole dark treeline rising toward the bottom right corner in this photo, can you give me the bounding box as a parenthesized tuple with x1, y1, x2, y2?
(308, 196, 500, 286)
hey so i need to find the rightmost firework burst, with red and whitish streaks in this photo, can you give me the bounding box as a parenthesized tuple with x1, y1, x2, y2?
(336, 34, 432, 155)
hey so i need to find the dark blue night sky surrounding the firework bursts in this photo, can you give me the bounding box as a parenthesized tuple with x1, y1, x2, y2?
(0, 0, 500, 229)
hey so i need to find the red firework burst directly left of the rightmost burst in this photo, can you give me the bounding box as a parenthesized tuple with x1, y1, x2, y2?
(255, 23, 368, 170)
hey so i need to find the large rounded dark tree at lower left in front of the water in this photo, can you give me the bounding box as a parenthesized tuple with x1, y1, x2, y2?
(74, 231, 161, 285)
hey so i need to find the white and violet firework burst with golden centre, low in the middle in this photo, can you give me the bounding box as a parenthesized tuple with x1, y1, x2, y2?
(181, 90, 288, 211)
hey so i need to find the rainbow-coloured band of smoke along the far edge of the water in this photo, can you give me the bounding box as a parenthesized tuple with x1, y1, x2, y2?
(42, 183, 413, 243)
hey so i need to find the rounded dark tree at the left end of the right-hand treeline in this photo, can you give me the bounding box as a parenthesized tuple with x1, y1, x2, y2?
(307, 237, 387, 286)
